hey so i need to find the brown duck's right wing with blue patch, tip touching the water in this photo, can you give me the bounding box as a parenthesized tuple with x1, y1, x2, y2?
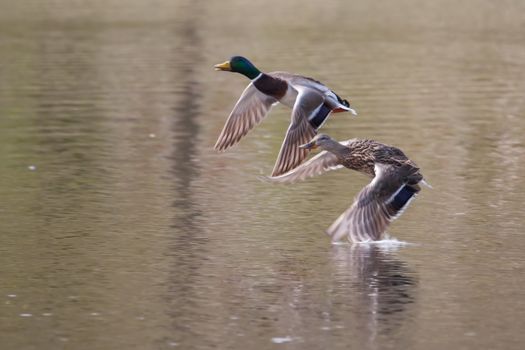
(327, 164, 419, 242)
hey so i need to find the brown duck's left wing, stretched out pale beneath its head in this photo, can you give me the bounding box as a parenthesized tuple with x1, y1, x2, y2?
(266, 140, 353, 183)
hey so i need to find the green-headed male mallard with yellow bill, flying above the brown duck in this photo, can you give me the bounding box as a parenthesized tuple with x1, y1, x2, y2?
(215, 56, 357, 176)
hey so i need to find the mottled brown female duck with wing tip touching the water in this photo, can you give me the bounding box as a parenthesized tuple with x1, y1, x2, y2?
(269, 134, 428, 242)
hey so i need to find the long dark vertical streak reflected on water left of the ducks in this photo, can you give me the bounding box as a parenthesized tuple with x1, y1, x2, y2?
(166, 2, 206, 344)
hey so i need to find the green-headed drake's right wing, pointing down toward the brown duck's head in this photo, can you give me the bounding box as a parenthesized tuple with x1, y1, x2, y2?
(272, 86, 324, 176)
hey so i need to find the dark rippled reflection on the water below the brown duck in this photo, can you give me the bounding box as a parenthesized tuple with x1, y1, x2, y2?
(332, 244, 418, 341)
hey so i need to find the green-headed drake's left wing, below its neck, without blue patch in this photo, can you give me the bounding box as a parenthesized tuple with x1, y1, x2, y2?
(215, 83, 278, 151)
